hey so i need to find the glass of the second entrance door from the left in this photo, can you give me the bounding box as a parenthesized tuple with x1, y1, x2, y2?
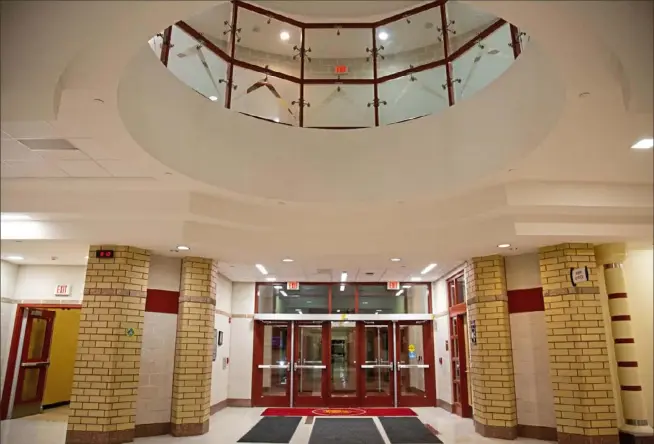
(296, 325, 324, 396)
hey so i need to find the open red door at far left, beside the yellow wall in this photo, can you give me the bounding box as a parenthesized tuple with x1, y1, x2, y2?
(9, 308, 55, 418)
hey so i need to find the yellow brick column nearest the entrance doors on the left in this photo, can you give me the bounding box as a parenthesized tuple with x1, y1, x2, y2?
(170, 257, 218, 436)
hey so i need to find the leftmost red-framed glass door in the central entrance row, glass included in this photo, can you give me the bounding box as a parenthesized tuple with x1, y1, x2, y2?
(252, 321, 291, 407)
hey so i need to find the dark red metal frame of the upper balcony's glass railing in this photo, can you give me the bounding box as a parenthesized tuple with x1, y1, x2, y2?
(170, 0, 522, 129)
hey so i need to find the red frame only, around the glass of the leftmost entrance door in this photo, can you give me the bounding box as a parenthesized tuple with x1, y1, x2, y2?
(251, 321, 292, 407)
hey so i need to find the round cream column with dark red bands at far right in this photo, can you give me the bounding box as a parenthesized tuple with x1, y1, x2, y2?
(595, 244, 654, 443)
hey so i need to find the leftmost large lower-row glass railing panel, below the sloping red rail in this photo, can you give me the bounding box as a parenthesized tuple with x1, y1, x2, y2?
(168, 26, 227, 105)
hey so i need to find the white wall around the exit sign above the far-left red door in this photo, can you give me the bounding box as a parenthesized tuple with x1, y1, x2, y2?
(14, 265, 86, 304)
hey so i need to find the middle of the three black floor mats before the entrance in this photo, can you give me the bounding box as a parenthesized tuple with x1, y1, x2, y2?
(309, 418, 384, 444)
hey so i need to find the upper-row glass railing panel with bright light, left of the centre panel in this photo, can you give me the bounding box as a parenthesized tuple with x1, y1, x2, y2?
(235, 8, 302, 78)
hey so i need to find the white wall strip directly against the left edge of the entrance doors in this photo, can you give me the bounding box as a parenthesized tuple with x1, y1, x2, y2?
(228, 282, 255, 399)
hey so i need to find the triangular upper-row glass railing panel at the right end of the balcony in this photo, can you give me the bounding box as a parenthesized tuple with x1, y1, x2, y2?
(445, 0, 498, 54)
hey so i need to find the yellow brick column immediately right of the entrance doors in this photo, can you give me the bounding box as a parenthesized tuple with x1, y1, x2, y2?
(465, 256, 518, 439)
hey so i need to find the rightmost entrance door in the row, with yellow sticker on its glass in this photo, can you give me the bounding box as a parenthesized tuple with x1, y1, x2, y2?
(396, 321, 436, 407)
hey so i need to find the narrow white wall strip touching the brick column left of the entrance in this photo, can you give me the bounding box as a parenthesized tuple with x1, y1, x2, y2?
(211, 275, 232, 405)
